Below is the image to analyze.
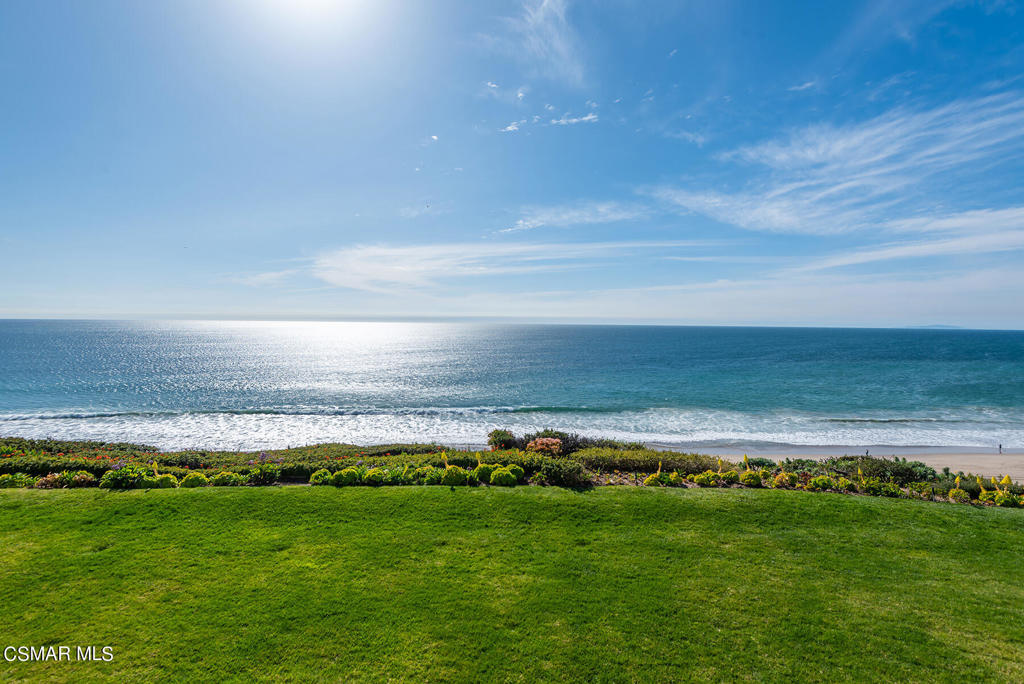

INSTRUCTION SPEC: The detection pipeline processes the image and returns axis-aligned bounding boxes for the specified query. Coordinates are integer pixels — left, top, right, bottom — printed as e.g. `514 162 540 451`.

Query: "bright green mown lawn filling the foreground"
0 487 1024 682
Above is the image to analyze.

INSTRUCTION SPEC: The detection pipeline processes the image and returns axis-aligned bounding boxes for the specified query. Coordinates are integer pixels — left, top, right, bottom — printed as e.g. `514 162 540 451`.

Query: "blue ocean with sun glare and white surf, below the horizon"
0 320 1024 448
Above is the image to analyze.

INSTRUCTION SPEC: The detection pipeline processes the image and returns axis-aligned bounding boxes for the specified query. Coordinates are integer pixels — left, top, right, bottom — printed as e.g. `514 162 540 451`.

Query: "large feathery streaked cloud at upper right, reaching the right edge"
650 92 1024 234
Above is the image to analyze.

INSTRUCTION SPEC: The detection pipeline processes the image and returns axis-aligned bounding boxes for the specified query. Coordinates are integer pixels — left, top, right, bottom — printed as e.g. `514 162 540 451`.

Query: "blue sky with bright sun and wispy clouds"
0 0 1024 329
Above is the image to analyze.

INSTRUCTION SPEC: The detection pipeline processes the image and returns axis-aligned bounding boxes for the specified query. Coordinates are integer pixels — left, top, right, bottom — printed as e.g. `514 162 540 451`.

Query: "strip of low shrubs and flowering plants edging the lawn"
0 438 1024 508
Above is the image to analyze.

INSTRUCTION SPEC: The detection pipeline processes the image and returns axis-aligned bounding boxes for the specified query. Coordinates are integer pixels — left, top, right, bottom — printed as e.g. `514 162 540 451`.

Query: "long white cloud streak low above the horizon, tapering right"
312 241 699 293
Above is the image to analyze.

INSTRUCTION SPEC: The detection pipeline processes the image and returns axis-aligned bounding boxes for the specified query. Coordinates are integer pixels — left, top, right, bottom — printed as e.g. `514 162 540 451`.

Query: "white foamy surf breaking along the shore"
0 407 1024 450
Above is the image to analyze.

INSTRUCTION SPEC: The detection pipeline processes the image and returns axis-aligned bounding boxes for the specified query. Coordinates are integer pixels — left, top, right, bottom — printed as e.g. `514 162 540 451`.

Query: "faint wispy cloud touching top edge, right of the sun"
500 0 585 87
